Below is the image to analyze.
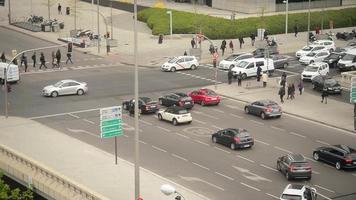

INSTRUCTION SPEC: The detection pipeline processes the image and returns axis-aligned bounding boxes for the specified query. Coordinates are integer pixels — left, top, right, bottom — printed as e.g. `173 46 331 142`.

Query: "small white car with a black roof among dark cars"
158 106 193 126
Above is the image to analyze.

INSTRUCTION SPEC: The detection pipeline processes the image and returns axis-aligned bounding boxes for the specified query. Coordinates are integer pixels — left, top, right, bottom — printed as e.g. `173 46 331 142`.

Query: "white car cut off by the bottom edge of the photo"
279 184 318 200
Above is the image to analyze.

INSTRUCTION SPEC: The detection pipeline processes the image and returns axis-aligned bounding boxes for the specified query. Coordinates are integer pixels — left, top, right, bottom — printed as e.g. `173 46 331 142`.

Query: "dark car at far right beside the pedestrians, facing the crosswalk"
312 76 342 94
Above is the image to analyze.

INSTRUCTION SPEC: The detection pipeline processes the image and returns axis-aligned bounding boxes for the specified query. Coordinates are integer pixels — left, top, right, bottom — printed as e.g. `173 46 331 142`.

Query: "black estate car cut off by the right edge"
313 145 356 170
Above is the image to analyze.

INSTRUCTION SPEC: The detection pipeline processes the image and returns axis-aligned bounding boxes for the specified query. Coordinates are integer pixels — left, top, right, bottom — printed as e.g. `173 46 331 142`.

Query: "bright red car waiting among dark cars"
188 88 221 106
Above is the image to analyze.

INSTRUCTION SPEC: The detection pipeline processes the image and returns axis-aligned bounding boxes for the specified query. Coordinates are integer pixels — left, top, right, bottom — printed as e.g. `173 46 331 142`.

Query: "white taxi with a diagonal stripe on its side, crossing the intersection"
161 56 199 72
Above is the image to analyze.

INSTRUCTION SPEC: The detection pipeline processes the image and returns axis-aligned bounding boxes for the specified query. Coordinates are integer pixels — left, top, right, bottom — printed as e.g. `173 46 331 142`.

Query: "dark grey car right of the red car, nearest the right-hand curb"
245 99 282 119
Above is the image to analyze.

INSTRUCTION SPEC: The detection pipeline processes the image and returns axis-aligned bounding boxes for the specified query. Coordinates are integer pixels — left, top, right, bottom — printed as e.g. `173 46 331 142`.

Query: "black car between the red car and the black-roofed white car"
158 92 194 109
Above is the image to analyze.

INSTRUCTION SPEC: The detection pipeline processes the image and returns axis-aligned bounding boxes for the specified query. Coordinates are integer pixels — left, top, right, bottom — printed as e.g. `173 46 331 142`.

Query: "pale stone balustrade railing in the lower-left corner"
0 144 107 200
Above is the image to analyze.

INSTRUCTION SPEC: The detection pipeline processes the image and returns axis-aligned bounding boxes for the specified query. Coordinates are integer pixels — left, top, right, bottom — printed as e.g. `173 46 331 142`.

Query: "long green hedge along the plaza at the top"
138 8 356 39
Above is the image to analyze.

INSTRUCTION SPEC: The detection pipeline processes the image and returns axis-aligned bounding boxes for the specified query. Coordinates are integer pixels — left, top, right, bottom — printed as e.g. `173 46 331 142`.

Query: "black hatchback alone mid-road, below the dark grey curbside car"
211 128 254 150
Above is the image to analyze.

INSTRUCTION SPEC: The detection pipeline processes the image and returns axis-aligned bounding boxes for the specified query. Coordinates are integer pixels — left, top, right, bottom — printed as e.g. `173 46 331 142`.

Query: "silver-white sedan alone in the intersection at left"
42 80 88 97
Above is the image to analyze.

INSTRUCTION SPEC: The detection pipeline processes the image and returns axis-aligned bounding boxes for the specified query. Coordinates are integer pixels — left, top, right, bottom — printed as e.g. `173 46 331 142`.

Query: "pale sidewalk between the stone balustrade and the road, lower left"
0 116 208 200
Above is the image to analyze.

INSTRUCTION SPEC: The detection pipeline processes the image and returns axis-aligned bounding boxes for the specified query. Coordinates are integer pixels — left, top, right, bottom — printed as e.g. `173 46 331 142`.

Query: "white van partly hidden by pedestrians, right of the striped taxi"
231 58 274 79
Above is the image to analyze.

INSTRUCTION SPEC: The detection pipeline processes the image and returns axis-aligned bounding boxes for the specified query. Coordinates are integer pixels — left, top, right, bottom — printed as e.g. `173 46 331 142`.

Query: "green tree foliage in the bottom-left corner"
0 172 34 200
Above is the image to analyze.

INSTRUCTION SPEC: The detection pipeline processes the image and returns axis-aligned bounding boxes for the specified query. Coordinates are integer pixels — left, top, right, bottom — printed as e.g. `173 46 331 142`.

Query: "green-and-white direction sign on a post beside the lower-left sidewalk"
100 106 123 164
